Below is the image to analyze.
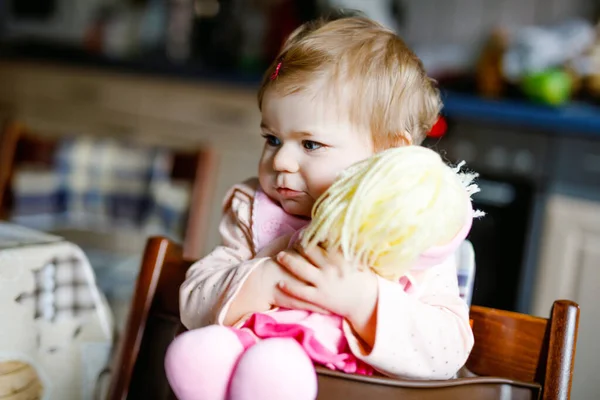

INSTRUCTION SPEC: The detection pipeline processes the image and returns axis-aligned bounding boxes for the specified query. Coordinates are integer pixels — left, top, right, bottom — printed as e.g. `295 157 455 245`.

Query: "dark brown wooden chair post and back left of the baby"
108 238 191 400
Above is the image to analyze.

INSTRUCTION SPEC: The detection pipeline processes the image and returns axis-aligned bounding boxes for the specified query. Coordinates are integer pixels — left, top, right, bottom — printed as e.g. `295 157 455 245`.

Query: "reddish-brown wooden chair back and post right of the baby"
466 300 579 399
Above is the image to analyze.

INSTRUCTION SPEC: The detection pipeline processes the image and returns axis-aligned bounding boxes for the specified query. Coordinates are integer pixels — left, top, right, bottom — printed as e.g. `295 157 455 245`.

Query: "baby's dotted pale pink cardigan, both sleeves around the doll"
180 179 473 379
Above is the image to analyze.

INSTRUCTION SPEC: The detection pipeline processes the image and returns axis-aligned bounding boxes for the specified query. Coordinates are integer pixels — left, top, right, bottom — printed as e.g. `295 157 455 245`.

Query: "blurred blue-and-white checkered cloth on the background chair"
13 137 190 238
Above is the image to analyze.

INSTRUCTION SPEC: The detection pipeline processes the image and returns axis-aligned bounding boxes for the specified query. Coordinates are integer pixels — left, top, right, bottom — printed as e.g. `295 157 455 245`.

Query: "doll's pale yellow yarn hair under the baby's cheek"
301 146 477 281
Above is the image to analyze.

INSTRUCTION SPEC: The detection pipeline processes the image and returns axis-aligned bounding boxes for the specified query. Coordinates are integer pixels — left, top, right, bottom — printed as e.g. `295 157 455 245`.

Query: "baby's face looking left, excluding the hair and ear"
259 90 374 217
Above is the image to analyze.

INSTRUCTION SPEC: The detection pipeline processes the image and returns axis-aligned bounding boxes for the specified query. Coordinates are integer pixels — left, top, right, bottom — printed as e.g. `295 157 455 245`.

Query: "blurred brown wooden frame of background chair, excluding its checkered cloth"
0 121 217 259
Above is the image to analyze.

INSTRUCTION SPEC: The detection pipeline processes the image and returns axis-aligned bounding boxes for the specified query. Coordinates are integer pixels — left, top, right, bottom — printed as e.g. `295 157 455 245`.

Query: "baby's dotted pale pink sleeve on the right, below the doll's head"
344 255 473 379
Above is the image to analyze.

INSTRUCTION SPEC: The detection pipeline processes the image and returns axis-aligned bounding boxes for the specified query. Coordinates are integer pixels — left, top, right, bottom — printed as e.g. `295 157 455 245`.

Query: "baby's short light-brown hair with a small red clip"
258 17 441 151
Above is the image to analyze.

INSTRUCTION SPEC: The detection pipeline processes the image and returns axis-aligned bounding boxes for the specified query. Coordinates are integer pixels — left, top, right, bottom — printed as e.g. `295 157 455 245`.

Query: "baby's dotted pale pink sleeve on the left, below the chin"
179 182 266 329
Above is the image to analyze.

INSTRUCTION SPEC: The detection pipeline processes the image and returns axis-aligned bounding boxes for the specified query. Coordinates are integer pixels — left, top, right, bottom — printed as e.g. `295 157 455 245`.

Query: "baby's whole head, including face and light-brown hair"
258 17 440 217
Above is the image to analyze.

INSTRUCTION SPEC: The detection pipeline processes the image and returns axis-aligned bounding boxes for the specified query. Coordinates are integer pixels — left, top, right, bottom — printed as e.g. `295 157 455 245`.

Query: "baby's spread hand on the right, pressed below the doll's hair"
276 246 378 330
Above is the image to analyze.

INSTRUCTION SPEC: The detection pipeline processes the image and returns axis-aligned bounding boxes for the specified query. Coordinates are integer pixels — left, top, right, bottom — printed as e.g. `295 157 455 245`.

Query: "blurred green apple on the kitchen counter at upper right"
521 69 573 106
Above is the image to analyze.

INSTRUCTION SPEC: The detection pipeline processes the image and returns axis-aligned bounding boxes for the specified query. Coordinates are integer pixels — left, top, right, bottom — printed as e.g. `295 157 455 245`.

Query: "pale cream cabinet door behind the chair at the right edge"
533 195 600 400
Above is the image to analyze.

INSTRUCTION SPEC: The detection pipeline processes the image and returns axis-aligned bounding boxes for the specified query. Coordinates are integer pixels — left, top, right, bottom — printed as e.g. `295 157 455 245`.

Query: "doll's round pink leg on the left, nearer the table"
165 325 244 400
